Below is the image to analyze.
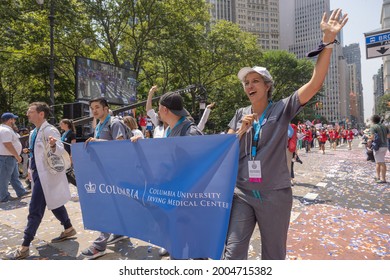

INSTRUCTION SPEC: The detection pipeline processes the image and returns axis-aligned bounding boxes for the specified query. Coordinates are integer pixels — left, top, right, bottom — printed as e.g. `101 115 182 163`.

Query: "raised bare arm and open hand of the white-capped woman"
298 9 348 105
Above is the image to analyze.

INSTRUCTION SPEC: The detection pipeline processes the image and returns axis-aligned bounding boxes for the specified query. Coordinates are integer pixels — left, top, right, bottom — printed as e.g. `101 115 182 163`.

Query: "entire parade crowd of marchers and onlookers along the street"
0 9 364 260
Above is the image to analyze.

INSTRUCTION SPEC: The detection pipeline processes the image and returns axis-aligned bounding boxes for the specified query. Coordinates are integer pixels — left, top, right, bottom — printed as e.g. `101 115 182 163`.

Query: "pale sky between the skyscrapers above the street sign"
330 0 383 122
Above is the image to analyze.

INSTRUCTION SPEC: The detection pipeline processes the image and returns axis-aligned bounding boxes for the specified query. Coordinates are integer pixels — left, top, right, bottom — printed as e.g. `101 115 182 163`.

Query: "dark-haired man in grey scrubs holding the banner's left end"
81 97 128 260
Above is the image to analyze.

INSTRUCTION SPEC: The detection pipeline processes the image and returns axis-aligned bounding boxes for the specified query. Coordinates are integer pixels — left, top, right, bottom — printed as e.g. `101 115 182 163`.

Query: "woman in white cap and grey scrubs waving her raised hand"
223 9 348 260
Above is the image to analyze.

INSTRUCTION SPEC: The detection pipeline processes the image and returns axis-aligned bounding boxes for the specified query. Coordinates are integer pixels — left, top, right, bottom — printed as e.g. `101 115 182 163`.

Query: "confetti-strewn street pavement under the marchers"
0 139 390 260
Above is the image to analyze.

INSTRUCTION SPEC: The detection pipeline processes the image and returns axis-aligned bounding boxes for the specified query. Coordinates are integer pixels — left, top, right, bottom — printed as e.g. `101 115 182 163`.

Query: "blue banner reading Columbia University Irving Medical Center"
72 135 239 259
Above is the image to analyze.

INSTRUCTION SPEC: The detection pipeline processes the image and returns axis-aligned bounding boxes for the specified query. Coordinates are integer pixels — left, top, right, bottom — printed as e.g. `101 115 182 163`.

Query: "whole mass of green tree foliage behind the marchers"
0 0 313 132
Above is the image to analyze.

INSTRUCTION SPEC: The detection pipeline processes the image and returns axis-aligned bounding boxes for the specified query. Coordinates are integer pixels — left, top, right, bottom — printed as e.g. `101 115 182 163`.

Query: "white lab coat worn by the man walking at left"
29 121 71 210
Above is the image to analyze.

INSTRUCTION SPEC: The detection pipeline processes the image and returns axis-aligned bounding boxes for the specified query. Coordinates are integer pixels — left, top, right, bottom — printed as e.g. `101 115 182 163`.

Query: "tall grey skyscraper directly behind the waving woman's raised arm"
279 0 349 123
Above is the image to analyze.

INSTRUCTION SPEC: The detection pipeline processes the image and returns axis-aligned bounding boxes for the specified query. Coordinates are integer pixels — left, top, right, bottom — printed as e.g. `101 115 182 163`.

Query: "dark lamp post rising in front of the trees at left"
36 0 55 124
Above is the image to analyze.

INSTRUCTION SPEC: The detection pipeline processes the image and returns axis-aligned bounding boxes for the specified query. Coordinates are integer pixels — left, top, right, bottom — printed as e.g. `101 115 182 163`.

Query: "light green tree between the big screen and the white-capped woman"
145 21 261 120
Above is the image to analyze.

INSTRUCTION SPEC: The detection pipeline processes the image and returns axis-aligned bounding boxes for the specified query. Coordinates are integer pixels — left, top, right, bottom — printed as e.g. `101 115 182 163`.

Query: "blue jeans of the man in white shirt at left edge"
0 156 26 202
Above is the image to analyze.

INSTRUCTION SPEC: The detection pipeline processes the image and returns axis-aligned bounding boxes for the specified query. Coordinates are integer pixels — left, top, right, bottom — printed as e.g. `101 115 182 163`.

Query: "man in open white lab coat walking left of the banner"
6 102 76 259
